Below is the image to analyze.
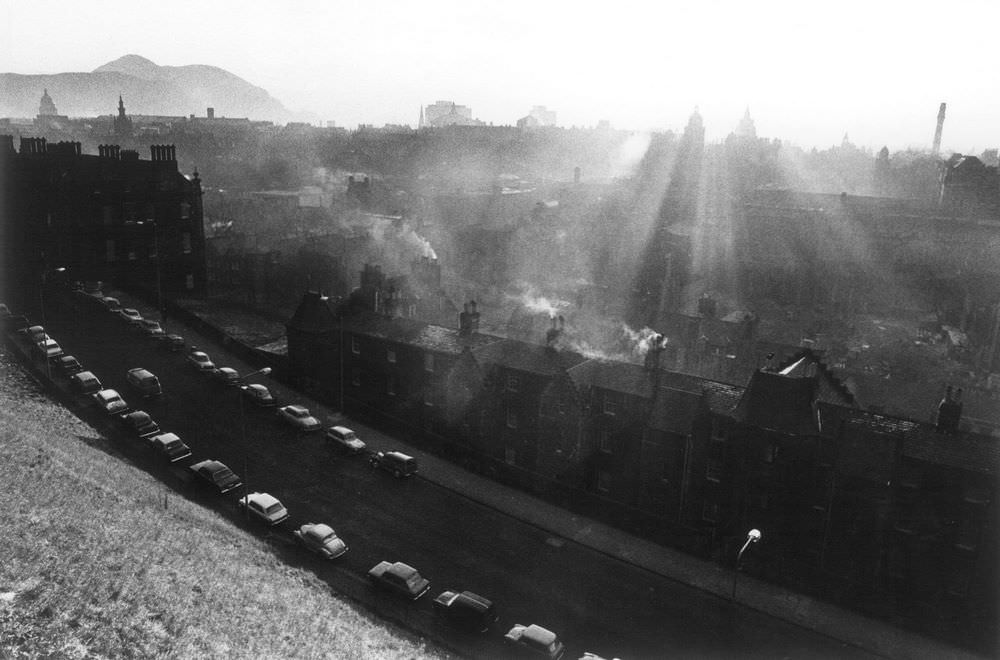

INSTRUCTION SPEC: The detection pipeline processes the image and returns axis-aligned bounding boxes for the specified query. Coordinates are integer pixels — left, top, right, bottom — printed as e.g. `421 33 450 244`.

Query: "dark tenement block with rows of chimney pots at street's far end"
0 136 206 310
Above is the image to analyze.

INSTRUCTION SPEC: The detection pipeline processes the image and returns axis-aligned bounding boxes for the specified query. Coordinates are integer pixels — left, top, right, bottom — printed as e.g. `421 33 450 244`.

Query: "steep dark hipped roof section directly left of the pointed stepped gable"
736 371 818 435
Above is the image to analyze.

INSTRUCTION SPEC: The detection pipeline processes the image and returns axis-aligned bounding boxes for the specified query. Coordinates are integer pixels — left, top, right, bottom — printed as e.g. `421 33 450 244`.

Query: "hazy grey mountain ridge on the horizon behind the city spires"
0 55 293 122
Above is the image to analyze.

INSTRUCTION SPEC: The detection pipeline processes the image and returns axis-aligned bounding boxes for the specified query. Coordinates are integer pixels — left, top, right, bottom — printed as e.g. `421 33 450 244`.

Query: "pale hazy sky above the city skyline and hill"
0 0 1000 153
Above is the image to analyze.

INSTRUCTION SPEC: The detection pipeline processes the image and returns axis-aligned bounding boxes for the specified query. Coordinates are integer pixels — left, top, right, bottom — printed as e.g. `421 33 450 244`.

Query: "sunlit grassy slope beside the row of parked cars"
0 349 443 658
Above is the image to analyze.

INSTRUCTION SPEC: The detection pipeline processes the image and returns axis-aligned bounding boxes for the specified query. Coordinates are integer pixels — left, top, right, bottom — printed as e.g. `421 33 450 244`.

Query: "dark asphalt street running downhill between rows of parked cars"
18 292 871 658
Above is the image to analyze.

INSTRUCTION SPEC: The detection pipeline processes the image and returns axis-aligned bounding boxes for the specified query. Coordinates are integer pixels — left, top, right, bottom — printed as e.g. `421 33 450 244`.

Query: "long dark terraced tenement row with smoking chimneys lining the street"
287 278 1000 644
